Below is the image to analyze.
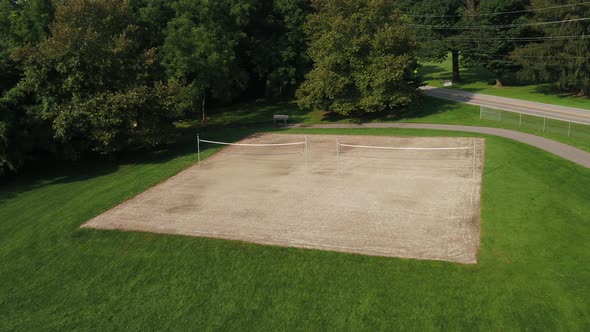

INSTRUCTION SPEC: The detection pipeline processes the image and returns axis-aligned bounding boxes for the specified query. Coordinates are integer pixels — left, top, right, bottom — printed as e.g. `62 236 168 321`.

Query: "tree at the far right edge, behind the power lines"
512 0 590 96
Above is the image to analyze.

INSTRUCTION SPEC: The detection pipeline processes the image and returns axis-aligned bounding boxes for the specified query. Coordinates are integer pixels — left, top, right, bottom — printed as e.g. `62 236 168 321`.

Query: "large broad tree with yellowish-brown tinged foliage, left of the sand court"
20 0 183 157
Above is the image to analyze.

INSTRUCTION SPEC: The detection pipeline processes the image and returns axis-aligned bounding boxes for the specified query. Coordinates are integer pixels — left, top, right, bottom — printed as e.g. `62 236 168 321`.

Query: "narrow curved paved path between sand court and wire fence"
290 123 590 168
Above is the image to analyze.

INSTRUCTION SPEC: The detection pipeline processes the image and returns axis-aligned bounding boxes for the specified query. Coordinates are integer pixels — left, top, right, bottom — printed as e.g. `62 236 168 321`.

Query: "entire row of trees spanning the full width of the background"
0 0 590 173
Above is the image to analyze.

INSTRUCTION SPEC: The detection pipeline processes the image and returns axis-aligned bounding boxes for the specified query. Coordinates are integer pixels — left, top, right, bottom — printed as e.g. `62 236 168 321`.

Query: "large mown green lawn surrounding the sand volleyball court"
0 128 590 331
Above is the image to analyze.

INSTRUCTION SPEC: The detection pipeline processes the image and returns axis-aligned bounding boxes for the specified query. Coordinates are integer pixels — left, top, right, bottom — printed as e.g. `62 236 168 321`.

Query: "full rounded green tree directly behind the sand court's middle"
297 0 420 115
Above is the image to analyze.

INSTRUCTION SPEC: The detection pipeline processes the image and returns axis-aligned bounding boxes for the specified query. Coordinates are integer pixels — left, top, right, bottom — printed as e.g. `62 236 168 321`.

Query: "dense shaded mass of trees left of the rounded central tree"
0 0 310 172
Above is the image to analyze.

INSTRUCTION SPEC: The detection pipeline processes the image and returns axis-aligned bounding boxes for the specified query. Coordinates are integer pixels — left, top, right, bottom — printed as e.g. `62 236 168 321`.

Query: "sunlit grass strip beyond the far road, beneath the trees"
420 57 590 110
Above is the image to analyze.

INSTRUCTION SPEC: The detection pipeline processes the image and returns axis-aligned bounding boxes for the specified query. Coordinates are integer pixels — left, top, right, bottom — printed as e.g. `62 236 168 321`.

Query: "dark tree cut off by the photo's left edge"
0 0 54 174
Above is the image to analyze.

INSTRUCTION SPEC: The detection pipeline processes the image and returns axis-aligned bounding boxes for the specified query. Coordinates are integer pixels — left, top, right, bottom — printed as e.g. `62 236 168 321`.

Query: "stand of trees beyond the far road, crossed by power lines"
408 0 590 96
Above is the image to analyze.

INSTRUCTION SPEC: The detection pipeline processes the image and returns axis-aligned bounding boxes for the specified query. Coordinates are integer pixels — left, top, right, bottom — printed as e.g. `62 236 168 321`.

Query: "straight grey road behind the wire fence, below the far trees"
422 86 590 125
